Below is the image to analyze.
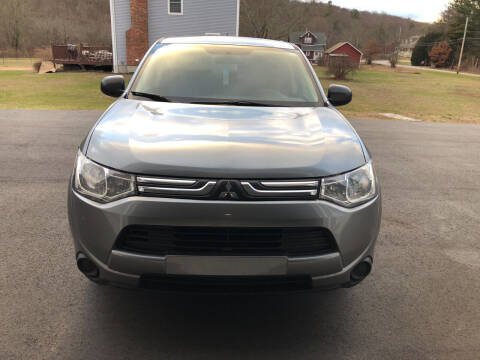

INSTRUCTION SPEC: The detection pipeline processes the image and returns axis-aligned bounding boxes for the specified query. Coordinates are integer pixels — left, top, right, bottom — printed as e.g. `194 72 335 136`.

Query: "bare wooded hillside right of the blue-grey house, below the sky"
240 0 430 53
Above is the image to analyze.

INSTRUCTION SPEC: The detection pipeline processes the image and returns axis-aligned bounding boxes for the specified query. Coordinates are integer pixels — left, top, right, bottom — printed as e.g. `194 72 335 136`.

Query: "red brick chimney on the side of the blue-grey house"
126 0 148 66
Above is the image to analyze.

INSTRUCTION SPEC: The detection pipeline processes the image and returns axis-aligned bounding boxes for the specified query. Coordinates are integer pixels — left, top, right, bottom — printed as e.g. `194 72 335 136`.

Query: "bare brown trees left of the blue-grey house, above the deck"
0 0 111 56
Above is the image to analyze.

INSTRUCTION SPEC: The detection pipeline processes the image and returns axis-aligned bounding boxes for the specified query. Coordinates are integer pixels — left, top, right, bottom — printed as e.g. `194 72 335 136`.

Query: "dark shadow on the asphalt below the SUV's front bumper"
67 284 349 358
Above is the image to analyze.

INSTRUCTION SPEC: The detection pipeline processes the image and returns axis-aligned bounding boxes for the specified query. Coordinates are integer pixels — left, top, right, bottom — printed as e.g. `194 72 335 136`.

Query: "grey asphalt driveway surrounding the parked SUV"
0 110 480 360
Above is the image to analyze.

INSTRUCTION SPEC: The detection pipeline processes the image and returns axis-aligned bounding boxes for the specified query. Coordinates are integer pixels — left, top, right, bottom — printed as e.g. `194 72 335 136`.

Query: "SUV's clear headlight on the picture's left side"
74 151 135 203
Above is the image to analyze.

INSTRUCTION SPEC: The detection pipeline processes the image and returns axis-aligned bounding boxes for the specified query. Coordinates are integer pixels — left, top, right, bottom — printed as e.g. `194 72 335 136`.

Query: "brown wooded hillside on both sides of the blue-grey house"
0 0 428 54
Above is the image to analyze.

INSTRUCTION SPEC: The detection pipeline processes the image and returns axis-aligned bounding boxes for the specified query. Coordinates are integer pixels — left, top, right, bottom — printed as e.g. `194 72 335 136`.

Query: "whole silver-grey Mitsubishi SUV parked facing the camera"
68 36 381 292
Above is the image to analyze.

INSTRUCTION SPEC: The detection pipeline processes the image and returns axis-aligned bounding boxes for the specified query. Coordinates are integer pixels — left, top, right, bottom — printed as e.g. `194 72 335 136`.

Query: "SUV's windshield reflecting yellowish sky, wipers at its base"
131 44 323 106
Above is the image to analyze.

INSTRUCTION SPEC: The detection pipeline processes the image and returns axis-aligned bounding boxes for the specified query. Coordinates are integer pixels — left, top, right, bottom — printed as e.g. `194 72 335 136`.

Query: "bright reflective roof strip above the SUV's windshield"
158 36 295 50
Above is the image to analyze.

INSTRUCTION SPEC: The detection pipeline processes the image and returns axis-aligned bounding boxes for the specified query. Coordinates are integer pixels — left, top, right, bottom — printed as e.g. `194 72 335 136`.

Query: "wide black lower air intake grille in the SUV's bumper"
116 225 337 257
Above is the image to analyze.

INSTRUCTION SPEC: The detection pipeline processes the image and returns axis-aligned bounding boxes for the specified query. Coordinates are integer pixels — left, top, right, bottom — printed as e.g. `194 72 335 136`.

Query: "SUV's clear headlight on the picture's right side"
320 162 377 207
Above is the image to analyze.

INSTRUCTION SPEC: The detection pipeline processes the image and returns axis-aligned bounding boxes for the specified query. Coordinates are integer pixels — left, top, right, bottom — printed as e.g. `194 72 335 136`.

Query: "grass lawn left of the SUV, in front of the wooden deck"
0 70 129 110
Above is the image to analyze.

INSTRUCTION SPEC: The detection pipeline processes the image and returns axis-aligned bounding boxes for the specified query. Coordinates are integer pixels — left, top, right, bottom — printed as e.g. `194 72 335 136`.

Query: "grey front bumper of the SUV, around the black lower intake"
68 183 381 288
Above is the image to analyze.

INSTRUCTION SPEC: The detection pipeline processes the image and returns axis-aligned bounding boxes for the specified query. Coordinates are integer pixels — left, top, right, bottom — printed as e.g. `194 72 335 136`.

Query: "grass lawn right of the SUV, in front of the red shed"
315 65 480 123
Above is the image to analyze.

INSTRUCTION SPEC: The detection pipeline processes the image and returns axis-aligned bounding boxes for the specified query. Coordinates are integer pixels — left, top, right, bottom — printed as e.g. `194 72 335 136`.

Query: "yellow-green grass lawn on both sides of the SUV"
0 64 480 123
